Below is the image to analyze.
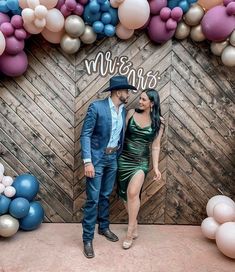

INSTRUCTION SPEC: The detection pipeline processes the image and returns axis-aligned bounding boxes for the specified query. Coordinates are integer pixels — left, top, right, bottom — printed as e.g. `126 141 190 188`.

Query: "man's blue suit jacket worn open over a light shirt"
80 98 126 165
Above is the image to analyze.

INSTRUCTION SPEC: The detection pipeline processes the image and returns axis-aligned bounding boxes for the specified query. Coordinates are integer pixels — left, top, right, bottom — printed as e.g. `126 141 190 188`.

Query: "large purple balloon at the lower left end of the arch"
0 51 28 77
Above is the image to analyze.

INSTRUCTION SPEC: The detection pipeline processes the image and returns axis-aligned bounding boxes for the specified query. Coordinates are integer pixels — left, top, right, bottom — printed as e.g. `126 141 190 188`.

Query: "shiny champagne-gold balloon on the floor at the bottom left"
0 214 19 237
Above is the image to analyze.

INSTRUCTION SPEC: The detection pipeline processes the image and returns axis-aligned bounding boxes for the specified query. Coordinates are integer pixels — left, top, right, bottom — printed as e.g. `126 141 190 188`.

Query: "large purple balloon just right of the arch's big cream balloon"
147 15 175 43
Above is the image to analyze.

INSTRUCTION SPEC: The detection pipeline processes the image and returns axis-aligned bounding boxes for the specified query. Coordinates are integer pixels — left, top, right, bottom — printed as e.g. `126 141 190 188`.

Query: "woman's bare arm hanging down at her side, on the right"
152 117 165 180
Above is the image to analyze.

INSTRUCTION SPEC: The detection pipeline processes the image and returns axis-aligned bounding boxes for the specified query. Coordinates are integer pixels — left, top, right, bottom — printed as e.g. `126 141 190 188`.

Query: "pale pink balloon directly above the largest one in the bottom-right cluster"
213 202 235 224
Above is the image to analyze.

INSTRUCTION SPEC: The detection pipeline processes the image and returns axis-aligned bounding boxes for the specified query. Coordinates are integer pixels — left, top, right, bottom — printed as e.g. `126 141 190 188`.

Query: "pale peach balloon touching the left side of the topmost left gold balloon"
46 8 64 32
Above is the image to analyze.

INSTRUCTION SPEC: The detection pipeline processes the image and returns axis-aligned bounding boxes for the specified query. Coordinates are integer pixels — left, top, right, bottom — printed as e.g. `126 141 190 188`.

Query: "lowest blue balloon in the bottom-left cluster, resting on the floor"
19 201 44 230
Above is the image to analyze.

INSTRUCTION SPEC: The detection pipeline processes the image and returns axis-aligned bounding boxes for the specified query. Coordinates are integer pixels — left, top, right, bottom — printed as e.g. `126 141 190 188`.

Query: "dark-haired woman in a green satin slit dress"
118 89 164 249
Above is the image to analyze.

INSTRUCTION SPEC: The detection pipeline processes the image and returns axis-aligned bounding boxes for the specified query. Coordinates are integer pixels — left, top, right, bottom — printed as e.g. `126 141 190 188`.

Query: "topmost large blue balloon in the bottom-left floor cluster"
12 174 39 201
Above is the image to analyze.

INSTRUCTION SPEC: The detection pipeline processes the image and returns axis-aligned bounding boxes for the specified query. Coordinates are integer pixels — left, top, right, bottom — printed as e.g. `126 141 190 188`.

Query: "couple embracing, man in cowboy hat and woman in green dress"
80 76 164 258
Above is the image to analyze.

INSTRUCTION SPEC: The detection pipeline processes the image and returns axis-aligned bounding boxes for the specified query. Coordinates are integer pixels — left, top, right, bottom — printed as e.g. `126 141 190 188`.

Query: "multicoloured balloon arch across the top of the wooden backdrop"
0 0 235 77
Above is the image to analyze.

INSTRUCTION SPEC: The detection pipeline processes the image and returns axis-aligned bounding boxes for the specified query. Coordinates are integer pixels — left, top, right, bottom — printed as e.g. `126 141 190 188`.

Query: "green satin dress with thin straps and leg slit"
117 116 154 201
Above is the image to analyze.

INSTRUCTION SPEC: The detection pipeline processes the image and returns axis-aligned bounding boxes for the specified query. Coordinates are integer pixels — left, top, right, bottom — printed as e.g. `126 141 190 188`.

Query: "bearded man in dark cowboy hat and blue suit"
80 76 136 258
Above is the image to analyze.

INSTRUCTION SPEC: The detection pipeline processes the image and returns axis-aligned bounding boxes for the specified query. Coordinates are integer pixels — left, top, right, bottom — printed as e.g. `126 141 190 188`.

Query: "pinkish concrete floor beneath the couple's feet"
0 224 235 272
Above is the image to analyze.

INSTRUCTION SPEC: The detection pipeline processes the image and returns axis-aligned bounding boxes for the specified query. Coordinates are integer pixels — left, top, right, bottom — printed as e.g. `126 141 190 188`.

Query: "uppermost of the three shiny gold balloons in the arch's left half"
64 15 85 38
